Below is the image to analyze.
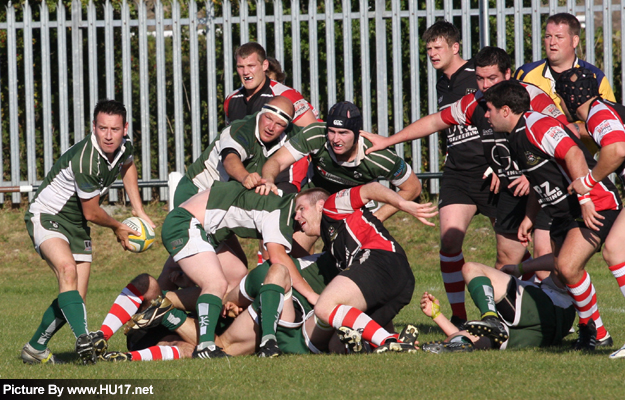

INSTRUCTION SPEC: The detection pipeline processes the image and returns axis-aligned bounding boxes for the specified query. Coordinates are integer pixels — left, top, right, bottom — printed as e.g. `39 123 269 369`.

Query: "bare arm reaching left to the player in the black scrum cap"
360 112 451 154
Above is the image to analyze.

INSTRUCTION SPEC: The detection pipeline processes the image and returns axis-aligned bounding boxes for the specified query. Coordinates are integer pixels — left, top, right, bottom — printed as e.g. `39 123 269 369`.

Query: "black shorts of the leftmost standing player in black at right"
438 171 498 218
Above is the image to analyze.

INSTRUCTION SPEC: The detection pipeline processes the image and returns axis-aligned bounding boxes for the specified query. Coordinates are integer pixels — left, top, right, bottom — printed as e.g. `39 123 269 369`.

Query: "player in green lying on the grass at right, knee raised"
421 255 575 353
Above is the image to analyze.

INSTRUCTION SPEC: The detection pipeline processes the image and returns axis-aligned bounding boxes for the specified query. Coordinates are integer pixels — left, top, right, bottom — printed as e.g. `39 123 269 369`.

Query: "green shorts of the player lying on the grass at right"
501 279 576 349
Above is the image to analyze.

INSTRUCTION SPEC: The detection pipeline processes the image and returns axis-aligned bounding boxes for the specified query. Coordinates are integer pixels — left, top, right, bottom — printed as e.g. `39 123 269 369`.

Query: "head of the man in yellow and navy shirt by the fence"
545 13 581 68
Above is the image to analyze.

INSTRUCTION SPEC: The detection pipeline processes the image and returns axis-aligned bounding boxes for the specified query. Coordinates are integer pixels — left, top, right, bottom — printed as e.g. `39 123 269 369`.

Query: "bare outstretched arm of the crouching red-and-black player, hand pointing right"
360 182 438 226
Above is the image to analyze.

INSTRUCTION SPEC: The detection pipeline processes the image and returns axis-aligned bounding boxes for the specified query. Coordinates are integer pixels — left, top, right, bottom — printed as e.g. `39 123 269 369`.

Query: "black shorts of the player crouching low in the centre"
339 249 415 326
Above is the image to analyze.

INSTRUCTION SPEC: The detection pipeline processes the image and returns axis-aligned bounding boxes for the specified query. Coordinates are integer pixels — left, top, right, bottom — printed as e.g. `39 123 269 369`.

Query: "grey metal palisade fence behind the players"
0 0 625 202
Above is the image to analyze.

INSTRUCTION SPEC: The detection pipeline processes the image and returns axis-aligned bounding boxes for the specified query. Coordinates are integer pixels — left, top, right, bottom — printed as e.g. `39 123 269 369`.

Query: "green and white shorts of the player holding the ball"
24 212 92 263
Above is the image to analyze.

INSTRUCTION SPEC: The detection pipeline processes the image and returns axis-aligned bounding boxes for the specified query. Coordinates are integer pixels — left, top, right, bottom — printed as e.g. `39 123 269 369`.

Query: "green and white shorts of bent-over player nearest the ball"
161 207 215 262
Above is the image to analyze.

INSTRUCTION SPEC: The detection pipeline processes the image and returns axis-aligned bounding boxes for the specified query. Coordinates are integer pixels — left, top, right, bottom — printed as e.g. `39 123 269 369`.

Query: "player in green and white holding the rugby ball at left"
21 100 155 364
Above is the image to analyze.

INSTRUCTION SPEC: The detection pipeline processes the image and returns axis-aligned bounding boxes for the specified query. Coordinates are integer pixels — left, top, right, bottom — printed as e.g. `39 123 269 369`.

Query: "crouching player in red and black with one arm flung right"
295 182 437 352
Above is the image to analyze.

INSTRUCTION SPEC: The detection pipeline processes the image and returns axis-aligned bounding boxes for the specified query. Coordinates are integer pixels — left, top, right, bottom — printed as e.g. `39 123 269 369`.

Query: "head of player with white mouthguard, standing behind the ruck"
234 42 269 92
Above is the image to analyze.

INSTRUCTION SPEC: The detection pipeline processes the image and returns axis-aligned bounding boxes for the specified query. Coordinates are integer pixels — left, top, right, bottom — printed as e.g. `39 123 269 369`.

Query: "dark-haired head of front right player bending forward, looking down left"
484 80 530 132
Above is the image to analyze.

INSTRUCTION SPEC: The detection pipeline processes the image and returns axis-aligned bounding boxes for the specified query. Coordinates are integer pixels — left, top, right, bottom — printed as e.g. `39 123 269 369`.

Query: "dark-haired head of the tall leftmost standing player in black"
422 20 460 71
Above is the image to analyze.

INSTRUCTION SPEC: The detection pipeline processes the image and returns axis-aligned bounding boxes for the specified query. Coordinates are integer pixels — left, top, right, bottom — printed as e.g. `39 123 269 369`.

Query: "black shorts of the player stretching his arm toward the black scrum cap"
494 190 551 234
